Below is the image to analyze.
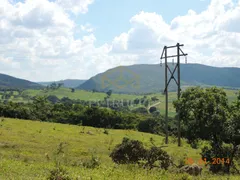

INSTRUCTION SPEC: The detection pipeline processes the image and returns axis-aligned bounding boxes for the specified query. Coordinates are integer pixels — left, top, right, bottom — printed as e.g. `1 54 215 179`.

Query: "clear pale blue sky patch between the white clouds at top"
72 0 210 45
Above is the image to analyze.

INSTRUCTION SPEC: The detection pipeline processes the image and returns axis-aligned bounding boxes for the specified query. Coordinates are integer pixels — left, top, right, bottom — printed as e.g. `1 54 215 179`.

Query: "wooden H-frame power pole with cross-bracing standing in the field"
160 43 188 146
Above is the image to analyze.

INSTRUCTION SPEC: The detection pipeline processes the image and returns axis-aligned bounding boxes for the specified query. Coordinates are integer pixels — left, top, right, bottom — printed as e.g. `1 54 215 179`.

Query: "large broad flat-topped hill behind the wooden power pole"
77 64 240 93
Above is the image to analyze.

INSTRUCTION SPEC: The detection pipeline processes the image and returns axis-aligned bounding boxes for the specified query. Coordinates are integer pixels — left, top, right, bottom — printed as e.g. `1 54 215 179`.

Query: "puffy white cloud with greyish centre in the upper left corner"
10 0 74 29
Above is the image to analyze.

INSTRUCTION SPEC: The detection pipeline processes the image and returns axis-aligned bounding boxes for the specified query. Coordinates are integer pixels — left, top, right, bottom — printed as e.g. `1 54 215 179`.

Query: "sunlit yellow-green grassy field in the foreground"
0 118 240 180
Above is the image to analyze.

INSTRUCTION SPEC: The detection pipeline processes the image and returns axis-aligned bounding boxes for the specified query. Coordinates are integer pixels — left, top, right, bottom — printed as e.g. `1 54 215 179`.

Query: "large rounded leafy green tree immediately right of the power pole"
173 87 229 143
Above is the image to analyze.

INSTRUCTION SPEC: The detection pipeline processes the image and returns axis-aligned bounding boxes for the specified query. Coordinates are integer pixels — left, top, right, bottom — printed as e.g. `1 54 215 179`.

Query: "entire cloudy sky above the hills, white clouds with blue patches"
0 0 240 81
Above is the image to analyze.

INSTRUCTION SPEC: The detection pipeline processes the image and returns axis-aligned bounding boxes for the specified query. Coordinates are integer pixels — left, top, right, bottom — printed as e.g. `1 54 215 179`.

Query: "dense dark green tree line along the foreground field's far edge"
0 96 170 133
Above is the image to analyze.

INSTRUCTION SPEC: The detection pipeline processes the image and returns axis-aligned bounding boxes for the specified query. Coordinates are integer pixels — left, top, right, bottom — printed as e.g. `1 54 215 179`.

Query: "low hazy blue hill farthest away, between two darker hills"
37 79 86 88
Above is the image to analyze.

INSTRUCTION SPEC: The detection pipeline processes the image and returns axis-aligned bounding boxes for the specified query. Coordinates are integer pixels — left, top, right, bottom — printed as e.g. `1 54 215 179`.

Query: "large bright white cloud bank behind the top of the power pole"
112 0 240 67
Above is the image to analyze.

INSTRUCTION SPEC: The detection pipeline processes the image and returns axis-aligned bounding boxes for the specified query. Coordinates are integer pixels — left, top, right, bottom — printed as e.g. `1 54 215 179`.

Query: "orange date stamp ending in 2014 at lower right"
185 158 230 165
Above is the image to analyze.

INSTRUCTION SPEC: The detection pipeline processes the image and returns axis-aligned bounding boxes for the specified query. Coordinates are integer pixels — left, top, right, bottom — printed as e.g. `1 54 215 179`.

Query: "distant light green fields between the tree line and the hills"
0 88 237 116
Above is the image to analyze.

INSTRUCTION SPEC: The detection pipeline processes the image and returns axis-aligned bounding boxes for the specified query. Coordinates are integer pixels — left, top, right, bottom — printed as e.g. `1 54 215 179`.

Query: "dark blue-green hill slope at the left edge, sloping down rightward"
0 74 42 89
